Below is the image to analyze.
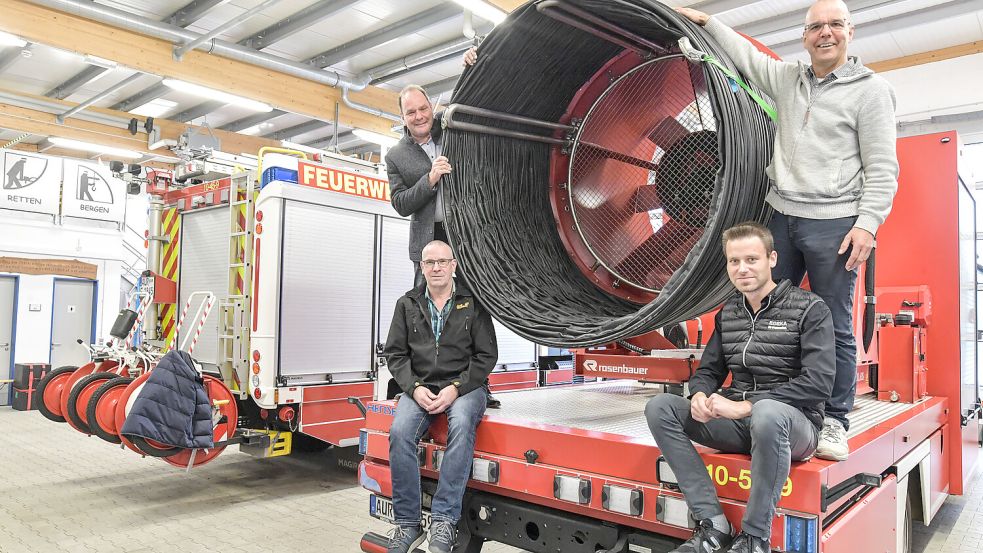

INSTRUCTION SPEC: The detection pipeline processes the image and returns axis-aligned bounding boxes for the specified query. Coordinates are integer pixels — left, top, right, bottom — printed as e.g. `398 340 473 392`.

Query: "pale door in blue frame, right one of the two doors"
50 279 96 368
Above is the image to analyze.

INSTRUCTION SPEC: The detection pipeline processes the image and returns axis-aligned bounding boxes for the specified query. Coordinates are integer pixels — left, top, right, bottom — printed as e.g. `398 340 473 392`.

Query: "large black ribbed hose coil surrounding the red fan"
442 0 774 347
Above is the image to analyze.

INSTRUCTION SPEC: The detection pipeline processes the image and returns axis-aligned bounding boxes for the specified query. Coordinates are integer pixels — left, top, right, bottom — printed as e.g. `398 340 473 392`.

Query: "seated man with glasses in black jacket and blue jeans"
385 240 498 553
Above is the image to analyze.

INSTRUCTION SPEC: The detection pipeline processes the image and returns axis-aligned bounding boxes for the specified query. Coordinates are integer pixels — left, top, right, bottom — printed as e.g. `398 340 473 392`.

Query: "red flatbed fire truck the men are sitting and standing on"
359 132 983 553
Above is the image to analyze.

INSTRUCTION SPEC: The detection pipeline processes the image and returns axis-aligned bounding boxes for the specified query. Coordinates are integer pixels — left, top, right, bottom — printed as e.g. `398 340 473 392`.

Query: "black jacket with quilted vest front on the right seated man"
689 280 836 428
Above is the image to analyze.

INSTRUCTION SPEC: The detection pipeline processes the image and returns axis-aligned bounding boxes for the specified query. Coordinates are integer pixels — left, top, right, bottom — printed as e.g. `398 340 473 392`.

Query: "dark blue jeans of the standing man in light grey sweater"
768 211 857 430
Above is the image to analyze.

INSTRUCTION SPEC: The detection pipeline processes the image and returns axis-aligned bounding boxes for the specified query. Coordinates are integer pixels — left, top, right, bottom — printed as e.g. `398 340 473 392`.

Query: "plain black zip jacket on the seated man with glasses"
385 282 498 396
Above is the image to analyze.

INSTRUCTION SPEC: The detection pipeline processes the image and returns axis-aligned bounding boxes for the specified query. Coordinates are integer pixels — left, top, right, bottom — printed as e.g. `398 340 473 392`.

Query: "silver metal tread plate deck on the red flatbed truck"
486 380 928 445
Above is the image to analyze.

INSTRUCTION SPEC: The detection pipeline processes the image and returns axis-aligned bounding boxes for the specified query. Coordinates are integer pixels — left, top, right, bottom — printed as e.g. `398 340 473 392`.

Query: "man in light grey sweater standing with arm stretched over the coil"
676 0 898 460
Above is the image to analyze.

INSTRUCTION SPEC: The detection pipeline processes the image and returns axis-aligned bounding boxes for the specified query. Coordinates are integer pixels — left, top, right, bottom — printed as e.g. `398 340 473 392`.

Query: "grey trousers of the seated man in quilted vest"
645 394 819 541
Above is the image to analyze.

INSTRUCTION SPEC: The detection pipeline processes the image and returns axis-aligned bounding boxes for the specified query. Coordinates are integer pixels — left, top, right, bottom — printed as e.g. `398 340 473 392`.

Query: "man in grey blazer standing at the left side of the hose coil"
386 85 500 408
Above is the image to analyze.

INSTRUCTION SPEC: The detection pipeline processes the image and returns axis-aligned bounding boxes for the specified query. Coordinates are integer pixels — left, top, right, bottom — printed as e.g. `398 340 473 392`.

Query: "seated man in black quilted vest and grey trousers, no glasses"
645 222 836 553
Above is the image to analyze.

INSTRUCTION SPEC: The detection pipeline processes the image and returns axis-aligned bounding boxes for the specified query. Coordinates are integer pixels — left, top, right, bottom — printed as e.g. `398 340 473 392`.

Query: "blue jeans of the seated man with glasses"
389 388 487 526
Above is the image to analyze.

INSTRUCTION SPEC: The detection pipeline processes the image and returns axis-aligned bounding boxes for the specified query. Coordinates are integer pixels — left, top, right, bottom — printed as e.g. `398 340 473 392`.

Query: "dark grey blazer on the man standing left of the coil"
386 112 444 262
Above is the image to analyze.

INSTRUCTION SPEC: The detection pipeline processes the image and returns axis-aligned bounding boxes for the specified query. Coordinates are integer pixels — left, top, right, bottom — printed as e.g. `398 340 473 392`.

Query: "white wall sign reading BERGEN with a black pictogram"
61 159 126 222
